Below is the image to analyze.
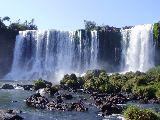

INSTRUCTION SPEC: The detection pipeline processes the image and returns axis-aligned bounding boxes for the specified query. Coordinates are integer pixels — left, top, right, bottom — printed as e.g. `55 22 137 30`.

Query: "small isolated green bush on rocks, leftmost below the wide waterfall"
33 78 52 90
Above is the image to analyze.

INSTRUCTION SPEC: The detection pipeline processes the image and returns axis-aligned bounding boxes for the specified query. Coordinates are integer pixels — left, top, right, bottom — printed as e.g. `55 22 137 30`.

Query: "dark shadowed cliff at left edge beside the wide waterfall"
0 29 18 79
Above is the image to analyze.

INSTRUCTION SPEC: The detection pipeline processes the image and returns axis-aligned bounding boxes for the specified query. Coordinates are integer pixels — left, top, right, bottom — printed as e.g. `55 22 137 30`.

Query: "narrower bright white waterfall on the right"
121 24 155 72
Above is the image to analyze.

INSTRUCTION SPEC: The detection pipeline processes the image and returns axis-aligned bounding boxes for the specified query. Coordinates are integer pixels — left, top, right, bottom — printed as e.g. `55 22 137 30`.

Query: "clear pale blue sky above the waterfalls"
0 0 160 30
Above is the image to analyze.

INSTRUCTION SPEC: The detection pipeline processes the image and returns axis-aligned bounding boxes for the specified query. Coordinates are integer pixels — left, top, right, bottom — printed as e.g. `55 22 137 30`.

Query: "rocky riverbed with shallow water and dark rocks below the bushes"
0 82 160 120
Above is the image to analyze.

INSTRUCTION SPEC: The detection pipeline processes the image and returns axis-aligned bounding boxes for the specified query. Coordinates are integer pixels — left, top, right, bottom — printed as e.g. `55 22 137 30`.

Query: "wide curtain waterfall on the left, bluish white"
5 30 99 80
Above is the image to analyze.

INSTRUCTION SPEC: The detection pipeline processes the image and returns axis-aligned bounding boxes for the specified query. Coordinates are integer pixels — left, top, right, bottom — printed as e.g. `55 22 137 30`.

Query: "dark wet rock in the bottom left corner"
0 110 23 120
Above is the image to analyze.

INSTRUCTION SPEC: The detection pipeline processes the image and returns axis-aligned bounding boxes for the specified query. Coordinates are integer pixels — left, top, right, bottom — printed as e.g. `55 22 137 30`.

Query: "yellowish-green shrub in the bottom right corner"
123 105 160 120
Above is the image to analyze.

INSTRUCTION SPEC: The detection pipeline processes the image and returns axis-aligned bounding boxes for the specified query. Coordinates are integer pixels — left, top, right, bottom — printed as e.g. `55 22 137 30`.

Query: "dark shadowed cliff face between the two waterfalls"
98 30 121 72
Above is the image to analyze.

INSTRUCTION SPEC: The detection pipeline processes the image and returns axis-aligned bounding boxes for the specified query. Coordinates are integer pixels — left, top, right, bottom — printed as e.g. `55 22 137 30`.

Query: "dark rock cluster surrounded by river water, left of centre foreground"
25 93 88 111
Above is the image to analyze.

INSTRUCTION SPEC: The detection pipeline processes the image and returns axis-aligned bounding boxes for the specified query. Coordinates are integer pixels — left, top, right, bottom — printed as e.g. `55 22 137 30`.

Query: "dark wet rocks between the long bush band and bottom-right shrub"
84 94 127 116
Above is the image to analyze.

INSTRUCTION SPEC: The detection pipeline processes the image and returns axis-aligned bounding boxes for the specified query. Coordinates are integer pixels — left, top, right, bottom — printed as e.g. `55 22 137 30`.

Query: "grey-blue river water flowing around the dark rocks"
0 81 160 120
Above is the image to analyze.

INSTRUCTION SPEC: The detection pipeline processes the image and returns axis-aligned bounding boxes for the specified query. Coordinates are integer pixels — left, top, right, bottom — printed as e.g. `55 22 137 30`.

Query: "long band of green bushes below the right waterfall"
60 66 160 99
